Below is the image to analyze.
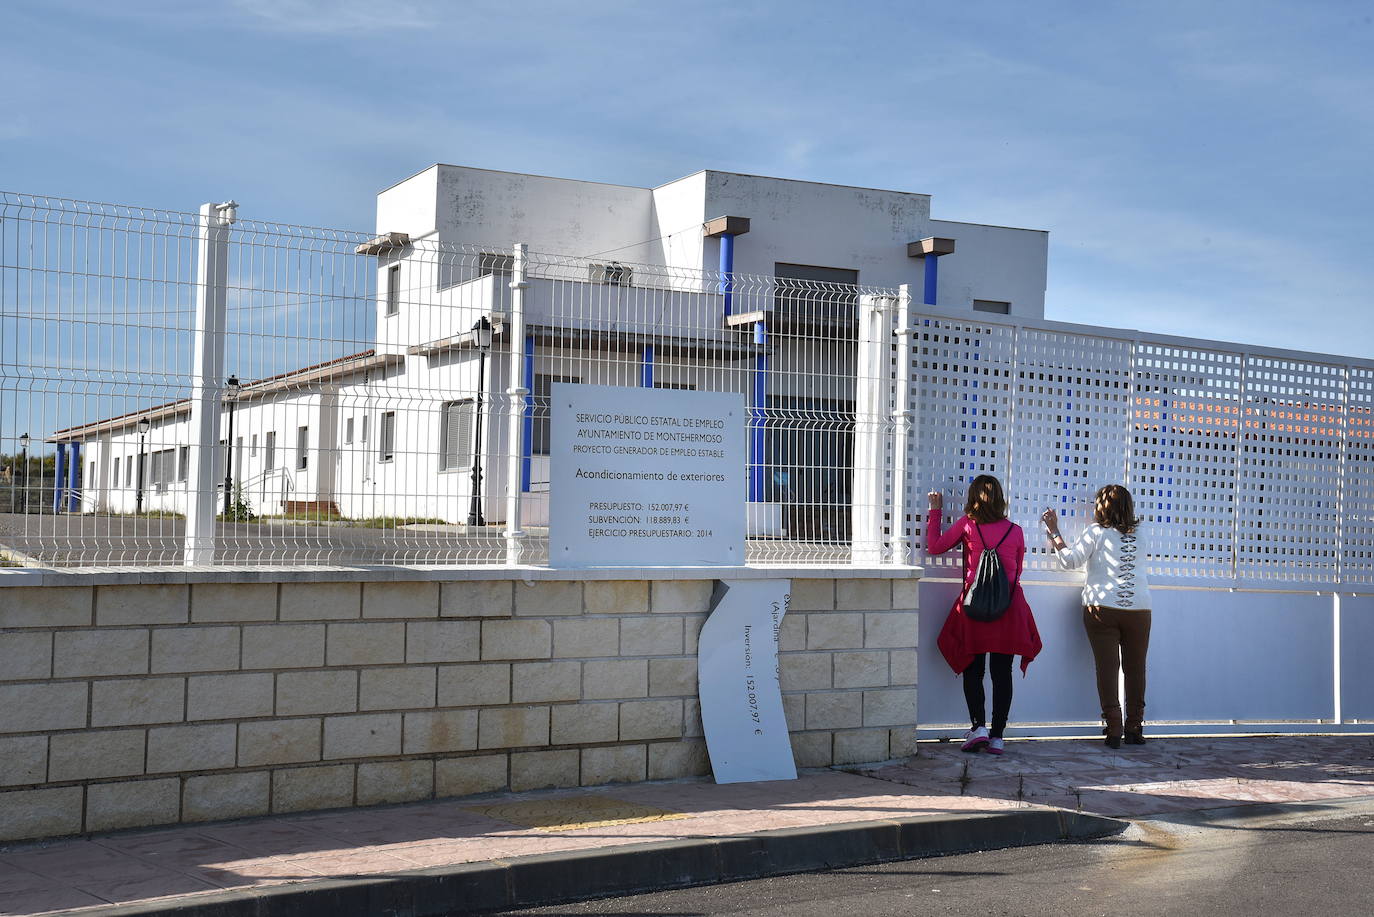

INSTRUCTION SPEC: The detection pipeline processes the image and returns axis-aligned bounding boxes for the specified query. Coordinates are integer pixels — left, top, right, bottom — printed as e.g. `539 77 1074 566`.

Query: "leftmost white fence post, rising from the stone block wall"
183 201 238 565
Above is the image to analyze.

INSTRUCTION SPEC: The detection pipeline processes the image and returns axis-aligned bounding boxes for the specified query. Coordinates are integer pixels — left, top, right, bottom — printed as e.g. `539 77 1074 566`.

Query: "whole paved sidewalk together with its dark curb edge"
0 736 1374 917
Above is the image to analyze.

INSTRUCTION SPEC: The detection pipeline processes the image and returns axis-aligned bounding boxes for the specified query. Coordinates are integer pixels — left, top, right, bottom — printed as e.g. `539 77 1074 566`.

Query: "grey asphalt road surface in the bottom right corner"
507 800 1374 917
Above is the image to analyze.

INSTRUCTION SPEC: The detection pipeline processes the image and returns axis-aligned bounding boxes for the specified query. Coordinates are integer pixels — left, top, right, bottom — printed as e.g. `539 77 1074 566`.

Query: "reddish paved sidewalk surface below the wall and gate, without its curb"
0 736 1374 916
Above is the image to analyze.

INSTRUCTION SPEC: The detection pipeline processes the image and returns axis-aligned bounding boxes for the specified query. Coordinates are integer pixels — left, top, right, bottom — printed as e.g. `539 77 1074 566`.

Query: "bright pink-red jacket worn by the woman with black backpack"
926 510 1041 675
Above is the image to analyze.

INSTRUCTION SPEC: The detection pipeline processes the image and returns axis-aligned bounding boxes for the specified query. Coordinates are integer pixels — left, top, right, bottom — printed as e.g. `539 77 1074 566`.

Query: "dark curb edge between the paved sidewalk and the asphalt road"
61 808 1129 917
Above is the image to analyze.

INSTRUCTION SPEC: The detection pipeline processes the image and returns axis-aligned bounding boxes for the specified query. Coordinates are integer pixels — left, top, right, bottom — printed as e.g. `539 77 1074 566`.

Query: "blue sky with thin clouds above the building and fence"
0 0 1374 357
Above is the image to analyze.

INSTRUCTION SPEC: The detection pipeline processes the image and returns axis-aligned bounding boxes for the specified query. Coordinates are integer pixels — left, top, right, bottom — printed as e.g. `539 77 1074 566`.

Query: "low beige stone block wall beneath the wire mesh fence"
0 573 916 840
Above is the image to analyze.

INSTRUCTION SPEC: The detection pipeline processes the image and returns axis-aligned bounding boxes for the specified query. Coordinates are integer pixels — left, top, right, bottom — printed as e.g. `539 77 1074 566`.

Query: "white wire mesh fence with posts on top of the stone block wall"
0 194 896 566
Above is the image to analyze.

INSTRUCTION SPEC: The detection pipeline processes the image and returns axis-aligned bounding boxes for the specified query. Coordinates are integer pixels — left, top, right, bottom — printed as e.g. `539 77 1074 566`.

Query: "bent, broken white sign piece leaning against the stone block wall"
697 580 797 784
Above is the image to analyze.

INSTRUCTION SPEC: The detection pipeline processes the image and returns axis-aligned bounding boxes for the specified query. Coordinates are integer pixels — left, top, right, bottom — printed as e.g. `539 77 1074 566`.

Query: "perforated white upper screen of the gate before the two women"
910 315 1374 591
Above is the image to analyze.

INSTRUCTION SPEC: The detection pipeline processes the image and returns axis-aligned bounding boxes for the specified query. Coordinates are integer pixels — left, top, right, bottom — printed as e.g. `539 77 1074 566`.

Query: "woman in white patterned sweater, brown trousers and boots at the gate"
1041 484 1150 748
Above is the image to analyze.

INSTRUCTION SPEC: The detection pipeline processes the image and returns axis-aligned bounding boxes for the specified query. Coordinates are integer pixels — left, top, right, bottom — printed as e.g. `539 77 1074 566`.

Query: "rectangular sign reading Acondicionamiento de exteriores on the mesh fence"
548 382 745 566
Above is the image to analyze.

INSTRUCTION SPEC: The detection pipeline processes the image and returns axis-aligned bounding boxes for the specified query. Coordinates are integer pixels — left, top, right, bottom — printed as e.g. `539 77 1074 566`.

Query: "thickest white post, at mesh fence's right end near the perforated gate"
851 296 892 564
